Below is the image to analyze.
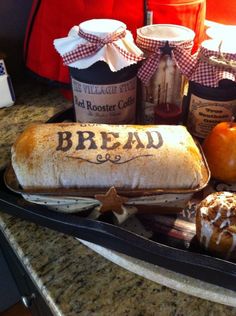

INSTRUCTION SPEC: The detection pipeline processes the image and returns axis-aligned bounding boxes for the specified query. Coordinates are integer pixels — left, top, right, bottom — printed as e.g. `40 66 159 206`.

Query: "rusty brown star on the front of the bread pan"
95 187 128 214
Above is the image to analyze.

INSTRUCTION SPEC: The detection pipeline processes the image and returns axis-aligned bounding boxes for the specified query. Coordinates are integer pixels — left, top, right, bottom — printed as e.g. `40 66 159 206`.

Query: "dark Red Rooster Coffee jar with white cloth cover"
54 19 143 124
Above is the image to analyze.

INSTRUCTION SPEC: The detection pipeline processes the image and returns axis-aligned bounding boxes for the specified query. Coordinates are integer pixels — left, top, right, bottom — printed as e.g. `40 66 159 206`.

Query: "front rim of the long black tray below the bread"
0 171 236 290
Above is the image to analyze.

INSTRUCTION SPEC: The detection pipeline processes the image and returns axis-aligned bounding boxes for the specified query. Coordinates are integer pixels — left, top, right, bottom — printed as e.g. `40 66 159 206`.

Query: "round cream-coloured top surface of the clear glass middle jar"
137 24 195 42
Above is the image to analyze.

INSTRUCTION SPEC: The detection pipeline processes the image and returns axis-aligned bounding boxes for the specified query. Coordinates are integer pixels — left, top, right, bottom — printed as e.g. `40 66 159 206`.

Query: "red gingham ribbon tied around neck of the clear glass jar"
136 28 195 85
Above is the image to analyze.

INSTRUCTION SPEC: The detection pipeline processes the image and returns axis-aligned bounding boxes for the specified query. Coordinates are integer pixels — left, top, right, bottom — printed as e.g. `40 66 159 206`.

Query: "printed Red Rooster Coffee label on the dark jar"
72 77 136 124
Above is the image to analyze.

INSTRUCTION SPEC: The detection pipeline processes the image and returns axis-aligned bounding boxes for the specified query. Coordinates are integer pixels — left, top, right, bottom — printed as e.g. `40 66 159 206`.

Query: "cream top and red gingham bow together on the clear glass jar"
136 24 195 84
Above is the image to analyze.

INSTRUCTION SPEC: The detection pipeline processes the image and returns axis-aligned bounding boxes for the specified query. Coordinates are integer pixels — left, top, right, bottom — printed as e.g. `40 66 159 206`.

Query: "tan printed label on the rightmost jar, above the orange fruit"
187 94 236 138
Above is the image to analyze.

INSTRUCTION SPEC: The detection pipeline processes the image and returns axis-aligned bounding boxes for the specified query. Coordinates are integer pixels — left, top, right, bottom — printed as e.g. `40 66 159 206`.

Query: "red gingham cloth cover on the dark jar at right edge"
188 40 236 88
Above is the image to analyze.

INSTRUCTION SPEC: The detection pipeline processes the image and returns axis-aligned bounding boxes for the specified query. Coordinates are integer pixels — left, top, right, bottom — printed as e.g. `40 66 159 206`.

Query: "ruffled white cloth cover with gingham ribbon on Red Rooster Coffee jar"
54 19 143 71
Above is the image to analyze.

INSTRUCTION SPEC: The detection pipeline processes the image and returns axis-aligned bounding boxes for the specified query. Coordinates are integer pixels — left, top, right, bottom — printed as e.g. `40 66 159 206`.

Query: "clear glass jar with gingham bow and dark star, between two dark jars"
137 24 194 124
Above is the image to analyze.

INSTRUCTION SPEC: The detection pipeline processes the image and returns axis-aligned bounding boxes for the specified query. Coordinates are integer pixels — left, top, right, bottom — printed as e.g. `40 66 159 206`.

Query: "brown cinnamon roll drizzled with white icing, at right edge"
196 192 236 260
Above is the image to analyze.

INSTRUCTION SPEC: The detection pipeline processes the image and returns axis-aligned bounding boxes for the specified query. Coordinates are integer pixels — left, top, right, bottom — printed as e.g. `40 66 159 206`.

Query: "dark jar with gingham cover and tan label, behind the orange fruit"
184 39 236 140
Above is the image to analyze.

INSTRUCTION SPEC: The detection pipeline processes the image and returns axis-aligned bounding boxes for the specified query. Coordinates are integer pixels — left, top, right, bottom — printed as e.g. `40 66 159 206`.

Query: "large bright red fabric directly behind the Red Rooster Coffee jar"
25 0 144 83
